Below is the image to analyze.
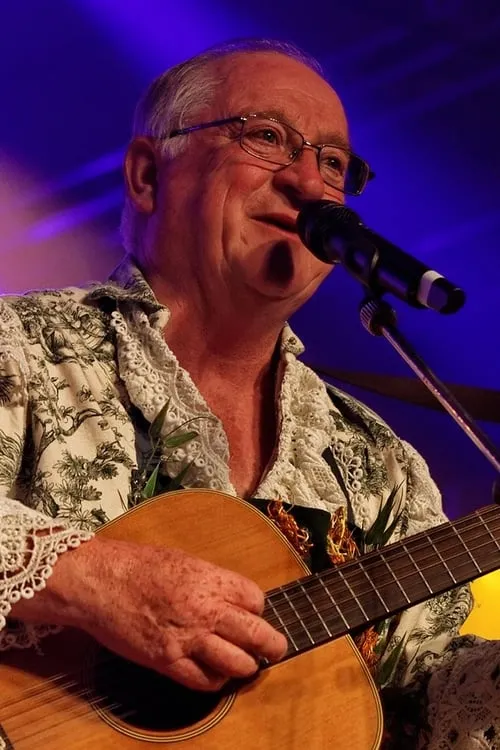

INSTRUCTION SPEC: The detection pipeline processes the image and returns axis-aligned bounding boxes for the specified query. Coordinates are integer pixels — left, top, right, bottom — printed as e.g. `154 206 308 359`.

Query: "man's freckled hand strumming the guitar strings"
12 539 287 690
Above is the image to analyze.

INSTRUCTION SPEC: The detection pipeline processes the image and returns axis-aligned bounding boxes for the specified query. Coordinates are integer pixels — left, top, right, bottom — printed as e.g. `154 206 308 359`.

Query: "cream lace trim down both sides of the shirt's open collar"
106 300 410 527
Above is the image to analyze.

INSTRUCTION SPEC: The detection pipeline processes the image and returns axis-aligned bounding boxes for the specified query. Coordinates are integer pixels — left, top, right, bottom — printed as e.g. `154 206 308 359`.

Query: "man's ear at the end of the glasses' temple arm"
123 136 158 215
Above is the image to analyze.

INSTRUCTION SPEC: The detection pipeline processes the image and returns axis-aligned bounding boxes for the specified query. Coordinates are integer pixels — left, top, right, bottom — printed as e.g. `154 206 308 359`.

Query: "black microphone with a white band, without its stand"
297 200 465 313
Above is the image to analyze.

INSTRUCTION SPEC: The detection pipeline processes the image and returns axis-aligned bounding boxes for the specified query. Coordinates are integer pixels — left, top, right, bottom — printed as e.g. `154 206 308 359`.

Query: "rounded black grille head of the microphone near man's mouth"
297 201 362 263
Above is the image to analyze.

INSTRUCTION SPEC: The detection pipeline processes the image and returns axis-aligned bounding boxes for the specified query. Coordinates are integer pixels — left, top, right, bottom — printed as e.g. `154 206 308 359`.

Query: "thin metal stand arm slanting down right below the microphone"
359 290 500 482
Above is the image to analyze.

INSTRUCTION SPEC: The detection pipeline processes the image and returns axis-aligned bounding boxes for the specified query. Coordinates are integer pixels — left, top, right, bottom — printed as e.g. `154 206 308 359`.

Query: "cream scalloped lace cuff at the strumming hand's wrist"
0 498 92 650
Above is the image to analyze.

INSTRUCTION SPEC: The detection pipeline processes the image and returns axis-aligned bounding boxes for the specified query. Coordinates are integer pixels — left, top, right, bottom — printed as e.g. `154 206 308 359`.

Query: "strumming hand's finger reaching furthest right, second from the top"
215 606 288 661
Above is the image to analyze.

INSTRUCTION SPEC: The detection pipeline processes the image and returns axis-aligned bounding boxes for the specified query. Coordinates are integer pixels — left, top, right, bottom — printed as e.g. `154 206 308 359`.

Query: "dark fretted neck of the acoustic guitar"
265 505 500 653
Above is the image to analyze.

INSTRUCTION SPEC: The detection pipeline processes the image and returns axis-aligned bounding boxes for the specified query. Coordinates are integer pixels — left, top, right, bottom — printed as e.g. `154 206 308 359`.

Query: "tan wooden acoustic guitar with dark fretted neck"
0 490 500 750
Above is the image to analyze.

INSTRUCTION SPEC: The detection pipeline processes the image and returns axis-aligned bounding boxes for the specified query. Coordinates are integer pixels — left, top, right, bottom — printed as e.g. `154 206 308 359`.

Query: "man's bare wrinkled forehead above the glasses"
205 52 348 142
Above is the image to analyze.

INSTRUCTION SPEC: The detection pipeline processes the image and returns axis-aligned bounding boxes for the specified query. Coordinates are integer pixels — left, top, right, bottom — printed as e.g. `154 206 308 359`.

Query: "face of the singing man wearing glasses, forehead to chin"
141 52 347 310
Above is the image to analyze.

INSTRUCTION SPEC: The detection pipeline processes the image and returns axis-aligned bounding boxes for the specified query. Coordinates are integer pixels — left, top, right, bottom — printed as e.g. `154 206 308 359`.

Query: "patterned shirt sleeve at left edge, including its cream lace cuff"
0 300 91 650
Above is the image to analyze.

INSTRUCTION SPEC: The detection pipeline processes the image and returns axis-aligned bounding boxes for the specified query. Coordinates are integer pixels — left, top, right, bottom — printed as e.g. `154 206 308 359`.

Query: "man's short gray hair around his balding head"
120 39 323 256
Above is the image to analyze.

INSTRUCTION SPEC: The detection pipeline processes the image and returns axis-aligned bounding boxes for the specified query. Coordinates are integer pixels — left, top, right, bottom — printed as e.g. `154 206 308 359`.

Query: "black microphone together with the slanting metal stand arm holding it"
297 200 500 487
